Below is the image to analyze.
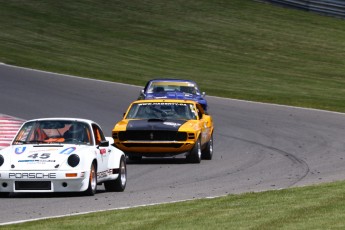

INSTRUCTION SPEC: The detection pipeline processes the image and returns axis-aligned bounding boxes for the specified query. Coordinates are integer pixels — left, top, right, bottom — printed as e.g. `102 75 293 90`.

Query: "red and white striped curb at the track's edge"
0 114 24 149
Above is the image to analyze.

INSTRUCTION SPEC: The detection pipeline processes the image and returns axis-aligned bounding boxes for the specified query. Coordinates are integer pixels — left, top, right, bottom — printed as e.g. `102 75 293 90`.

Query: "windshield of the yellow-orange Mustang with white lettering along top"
126 102 196 120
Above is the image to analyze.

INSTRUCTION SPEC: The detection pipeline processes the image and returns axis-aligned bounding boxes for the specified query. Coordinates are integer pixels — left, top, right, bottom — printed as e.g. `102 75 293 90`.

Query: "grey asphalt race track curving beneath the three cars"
0 65 345 224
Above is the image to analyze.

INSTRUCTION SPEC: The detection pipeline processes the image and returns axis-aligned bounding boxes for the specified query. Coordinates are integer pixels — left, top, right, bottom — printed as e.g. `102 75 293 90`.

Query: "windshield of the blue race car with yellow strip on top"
147 82 200 95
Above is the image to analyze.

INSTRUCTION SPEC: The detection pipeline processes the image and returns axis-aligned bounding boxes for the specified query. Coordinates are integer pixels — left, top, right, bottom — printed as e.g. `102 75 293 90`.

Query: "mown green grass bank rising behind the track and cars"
0 0 345 112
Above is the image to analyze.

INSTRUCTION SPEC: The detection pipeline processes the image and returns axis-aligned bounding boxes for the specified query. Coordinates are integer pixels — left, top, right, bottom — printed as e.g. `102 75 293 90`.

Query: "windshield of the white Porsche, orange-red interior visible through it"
13 120 91 145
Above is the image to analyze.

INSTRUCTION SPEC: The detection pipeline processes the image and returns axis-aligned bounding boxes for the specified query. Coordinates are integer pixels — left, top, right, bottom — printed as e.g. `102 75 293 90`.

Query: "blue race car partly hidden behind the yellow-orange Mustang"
138 79 207 111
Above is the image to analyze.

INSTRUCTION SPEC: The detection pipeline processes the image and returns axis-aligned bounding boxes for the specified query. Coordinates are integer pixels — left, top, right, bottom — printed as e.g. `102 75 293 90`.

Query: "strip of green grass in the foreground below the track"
0 182 345 230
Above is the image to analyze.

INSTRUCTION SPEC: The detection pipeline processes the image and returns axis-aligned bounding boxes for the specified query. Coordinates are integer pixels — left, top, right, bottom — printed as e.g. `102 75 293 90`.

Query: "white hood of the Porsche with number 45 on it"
1 145 86 170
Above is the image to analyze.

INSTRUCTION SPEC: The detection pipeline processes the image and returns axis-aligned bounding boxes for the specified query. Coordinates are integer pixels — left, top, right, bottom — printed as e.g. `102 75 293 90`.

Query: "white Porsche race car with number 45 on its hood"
0 118 127 196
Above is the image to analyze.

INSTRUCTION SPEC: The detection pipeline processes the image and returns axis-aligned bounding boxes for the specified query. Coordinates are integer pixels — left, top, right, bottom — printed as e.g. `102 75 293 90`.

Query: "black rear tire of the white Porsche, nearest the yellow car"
104 156 127 192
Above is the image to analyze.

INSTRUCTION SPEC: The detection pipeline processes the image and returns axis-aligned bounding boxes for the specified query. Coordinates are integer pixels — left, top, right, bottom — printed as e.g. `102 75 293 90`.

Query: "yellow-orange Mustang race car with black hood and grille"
112 99 213 163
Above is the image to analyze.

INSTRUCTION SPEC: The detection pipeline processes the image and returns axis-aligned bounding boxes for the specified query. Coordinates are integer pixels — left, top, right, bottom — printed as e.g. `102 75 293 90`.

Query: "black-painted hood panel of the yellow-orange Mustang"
127 119 187 131
